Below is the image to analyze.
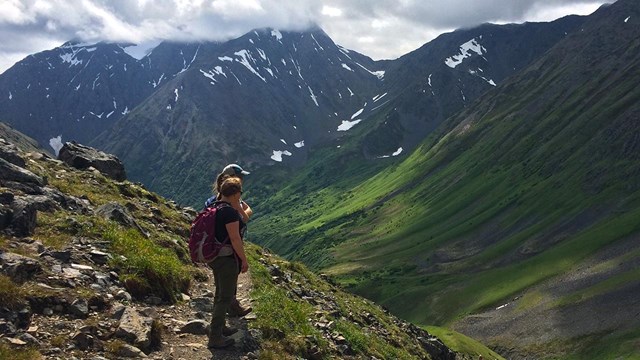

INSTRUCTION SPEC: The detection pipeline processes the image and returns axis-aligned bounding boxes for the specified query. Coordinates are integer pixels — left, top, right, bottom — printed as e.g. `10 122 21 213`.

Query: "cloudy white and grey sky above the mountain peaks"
0 0 615 73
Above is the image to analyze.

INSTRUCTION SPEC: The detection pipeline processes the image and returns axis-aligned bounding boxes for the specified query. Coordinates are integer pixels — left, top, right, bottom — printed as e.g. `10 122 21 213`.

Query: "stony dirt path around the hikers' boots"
149 273 257 360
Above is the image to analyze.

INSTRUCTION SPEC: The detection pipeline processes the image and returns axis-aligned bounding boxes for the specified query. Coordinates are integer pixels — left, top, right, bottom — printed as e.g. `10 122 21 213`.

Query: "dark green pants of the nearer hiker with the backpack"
209 255 238 338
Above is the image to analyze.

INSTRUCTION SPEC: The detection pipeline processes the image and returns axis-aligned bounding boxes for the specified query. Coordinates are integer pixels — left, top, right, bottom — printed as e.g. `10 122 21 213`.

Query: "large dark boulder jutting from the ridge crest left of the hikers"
58 142 127 181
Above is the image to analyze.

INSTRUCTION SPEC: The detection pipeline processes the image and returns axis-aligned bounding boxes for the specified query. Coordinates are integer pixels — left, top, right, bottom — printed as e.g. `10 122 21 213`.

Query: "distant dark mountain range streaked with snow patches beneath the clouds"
0 16 583 205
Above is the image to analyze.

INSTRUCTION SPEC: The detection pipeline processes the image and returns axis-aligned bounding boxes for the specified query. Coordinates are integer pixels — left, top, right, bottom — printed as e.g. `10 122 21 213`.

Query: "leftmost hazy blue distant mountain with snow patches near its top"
0 41 206 155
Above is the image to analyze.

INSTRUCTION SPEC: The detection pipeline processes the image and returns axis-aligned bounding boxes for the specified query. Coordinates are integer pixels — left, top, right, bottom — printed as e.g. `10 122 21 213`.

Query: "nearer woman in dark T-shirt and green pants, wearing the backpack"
207 177 249 349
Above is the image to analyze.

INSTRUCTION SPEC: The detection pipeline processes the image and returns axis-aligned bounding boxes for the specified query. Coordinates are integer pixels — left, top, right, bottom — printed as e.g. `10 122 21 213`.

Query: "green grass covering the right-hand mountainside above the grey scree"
252 2 640 353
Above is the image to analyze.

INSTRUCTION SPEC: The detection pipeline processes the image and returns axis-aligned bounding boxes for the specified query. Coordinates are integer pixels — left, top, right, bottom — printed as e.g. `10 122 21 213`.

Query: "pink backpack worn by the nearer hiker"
189 203 231 264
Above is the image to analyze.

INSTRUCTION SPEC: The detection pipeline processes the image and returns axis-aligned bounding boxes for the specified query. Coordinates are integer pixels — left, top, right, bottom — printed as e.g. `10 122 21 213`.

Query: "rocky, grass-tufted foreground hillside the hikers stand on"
0 125 490 360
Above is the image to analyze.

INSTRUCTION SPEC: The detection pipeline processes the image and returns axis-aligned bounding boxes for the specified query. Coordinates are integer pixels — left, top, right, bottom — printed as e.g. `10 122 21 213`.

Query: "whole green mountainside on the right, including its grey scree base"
252 0 640 359
